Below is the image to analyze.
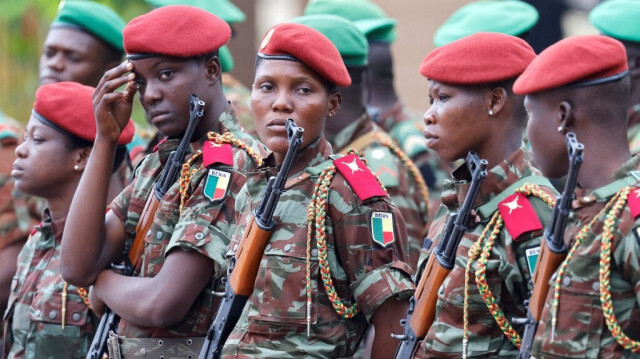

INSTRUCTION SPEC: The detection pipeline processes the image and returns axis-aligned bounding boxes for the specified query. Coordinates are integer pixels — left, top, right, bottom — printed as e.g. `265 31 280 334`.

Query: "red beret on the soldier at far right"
513 35 629 95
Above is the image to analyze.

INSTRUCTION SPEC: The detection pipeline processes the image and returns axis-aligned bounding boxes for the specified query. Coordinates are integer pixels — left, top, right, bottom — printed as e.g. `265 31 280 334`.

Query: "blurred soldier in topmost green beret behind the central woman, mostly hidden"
304 0 450 202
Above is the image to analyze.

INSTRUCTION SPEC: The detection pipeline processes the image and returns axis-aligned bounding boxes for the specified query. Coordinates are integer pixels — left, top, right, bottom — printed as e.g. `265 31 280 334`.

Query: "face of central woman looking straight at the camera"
251 60 340 155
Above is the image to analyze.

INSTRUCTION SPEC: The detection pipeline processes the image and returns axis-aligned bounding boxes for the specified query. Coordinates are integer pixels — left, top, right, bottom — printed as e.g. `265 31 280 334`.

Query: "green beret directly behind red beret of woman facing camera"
291 14 369 66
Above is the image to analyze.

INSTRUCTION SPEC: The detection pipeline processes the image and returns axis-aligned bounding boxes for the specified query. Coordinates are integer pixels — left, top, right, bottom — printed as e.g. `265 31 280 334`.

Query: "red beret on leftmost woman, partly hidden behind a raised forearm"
33 82 135 145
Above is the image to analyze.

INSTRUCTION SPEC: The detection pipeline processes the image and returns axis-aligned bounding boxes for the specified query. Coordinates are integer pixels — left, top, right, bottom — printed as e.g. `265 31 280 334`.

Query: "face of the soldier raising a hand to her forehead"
131 56 211 137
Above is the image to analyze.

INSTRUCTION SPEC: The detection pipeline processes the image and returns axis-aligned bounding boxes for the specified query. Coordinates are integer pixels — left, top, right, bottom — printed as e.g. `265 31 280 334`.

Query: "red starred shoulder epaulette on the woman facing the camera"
333 154 387 201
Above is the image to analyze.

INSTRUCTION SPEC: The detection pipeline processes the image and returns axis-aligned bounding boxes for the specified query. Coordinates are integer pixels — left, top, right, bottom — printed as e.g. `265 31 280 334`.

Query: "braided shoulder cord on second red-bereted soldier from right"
462 183 555 358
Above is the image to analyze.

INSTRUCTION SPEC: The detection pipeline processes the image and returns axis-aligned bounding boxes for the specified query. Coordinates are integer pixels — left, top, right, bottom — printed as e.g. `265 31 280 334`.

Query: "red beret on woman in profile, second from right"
420 32 536 85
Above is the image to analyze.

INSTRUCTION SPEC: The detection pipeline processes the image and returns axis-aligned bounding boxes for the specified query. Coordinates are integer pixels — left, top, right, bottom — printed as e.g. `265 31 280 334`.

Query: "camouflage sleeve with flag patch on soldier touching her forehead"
165 166 245 278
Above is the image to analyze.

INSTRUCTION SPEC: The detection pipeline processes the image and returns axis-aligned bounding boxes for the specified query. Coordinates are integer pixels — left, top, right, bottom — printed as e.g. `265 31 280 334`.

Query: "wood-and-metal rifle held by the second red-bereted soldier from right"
391 151 489 359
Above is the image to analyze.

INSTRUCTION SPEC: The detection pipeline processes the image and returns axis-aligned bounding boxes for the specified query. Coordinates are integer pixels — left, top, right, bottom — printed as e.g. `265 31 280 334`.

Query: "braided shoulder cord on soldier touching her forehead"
180 132 263 213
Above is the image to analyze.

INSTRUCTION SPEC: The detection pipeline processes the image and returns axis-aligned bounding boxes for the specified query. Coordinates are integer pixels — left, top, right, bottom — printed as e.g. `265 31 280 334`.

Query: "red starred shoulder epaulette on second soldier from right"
498 192 542 240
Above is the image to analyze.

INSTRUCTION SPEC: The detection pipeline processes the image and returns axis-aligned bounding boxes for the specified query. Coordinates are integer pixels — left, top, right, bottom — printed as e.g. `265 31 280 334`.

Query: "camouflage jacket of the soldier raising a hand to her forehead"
110 112 262 338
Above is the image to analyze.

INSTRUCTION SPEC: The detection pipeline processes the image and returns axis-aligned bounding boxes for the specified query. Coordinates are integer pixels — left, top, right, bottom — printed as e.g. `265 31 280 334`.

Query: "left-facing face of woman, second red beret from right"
424 80 491 162
